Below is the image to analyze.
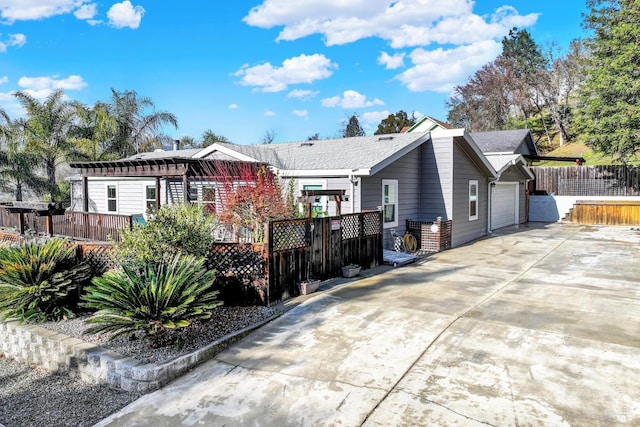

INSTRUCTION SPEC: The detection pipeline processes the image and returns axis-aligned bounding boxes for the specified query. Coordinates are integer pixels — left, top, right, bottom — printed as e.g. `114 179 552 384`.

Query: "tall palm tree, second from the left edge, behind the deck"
14 89 77 201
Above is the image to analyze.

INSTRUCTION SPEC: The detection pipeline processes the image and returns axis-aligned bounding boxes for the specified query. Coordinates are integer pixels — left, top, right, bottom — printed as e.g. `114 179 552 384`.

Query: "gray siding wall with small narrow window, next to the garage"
451 143 488 247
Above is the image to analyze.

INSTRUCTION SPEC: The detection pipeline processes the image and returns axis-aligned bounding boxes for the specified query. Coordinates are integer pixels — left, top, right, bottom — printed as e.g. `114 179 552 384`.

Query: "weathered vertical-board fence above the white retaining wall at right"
531 165 640 196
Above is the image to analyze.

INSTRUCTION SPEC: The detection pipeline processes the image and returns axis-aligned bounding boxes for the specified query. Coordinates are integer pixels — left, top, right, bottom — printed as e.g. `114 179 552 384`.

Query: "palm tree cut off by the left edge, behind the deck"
0 113 48 201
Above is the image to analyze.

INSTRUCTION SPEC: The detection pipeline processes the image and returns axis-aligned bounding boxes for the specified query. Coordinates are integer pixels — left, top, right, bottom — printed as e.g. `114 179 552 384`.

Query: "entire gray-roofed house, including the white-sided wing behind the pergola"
73 129 498 249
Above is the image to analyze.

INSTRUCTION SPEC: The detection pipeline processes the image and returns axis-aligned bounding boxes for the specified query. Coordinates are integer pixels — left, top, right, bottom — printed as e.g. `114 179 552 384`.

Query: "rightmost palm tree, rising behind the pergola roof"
107 89 178 158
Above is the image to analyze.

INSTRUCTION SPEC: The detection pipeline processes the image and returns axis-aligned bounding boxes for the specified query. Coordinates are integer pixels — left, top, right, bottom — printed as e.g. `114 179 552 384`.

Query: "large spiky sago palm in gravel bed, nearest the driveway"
81 253 222 343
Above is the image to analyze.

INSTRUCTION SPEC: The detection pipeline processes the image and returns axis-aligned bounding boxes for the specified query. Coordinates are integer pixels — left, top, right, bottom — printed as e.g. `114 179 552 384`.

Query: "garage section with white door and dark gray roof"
471 129 539 231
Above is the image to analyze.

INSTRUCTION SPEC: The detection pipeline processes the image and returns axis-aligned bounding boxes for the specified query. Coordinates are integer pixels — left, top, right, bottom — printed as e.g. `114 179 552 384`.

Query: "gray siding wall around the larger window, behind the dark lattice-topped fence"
360 147 422 249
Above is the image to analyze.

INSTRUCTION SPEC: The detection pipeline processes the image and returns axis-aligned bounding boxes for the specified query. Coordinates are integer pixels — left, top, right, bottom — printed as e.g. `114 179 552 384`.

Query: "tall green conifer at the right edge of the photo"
576 0 640 162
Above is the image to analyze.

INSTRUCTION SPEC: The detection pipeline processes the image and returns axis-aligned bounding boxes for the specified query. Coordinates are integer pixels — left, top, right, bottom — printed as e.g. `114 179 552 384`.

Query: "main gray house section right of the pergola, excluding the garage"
196 129 497 248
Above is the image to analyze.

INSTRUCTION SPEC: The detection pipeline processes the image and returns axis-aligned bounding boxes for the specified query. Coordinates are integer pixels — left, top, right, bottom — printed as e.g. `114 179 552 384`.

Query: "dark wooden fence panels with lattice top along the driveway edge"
268 211 383 303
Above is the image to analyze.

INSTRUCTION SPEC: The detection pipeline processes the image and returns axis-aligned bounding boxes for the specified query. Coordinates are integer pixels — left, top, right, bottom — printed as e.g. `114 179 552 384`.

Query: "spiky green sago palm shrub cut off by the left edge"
0 239 90 322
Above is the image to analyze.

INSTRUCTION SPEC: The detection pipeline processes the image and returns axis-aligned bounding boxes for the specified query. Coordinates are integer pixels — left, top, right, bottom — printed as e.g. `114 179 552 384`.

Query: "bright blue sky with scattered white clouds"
0 0 586 144
